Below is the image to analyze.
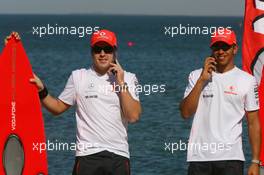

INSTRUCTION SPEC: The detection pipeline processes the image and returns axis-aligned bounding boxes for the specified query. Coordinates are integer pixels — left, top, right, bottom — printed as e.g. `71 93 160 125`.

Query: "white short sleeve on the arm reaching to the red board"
59 75 76 105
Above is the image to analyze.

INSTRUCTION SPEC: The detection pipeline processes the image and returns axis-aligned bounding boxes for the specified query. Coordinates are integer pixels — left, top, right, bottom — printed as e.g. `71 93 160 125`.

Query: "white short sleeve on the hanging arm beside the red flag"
245 78 259 111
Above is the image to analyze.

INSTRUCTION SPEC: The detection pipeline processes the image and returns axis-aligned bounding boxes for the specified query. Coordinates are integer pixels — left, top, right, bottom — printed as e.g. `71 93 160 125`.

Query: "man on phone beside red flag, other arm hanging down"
180 28 261 175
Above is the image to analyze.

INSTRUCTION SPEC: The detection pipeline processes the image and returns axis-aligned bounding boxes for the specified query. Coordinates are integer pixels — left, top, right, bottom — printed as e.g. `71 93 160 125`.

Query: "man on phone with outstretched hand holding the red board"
30 30 141 175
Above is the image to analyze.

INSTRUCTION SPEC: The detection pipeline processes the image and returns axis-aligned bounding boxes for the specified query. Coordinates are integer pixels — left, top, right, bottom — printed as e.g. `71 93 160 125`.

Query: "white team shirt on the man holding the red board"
59 68 139 158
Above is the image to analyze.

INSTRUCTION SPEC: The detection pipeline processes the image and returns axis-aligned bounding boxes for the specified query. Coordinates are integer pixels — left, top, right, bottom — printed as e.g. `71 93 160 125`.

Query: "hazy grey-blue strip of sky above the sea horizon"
0 0 245 16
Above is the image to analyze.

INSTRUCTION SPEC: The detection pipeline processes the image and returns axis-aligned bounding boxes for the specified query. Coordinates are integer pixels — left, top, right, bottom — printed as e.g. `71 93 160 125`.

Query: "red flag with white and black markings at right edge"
242 0 264 163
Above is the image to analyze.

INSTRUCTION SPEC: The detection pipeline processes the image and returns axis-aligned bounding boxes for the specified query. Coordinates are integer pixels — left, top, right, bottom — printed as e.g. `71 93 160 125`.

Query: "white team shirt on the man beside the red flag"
184 67 259 162
